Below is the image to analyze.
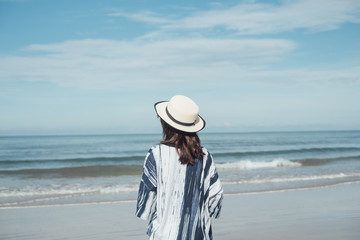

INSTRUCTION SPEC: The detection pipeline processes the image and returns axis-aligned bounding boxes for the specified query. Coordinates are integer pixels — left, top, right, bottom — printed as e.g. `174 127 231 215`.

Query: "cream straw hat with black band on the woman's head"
154 95 205 133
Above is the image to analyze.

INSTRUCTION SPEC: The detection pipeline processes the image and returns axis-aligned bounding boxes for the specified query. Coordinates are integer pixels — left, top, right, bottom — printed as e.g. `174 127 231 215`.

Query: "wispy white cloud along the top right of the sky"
111 0 360 34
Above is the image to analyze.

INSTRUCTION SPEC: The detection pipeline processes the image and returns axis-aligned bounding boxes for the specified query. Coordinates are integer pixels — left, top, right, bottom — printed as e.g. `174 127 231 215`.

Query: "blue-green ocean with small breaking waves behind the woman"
0 131 360 209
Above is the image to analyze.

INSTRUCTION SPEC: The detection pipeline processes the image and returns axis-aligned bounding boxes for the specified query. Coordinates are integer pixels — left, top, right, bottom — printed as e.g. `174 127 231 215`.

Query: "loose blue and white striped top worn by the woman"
136 144 223 240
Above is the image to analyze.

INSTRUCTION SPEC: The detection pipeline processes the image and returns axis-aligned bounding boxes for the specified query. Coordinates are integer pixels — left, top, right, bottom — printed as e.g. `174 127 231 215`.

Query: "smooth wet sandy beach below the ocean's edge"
0 183 360 240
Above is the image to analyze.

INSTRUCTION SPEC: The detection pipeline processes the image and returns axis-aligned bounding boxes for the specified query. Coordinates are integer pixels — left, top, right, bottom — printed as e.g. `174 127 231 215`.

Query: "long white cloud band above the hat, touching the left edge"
0 38 296 88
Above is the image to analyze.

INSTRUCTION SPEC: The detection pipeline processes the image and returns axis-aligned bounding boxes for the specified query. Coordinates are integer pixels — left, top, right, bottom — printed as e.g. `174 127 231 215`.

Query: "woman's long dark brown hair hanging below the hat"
160 118 205 164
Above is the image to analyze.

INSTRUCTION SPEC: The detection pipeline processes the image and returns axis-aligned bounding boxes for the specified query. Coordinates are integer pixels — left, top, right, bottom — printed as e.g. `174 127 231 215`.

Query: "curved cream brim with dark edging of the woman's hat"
154 101 205 133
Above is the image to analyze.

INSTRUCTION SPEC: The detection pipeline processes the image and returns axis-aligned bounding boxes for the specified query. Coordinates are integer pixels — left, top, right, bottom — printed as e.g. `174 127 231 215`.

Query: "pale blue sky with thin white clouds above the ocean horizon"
0 0 360 135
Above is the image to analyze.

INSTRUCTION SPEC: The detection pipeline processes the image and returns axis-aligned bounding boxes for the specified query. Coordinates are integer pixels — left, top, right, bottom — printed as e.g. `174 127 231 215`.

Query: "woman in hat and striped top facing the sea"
136 95 223 240
